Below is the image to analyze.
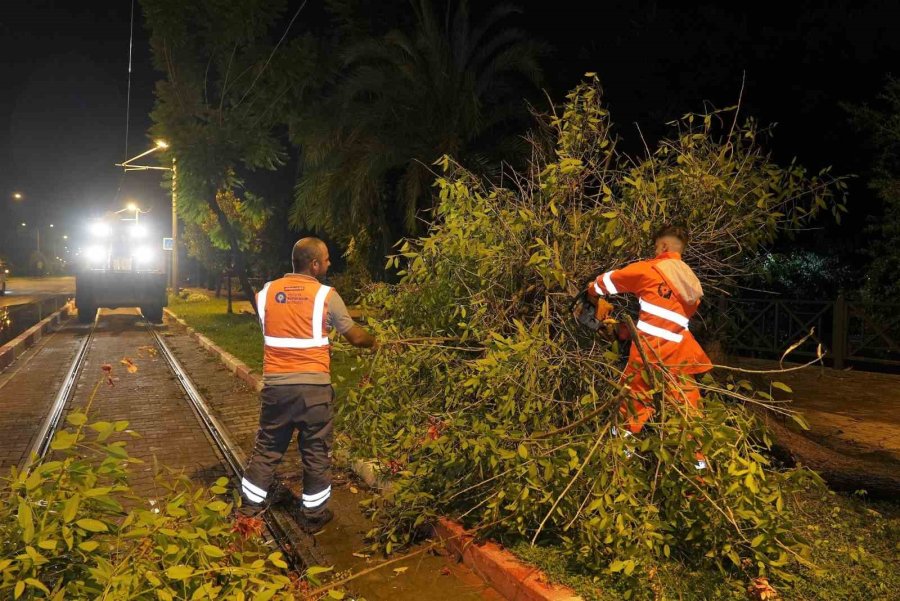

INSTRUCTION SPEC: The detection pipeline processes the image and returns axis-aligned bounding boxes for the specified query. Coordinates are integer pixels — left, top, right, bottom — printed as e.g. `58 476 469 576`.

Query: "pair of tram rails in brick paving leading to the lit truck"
20 312 330 573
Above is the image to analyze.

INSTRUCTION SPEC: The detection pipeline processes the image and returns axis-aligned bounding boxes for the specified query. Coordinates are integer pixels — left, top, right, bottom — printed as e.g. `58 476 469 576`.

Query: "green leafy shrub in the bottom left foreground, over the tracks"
0 413 295 601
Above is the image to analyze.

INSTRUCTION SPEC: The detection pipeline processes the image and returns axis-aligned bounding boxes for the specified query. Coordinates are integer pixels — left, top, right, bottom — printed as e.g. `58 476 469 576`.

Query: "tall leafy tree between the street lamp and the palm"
142 0 314 310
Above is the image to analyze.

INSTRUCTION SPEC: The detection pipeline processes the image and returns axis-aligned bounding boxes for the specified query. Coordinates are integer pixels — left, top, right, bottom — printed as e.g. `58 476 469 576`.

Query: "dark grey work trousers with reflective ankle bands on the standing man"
241 384 334 518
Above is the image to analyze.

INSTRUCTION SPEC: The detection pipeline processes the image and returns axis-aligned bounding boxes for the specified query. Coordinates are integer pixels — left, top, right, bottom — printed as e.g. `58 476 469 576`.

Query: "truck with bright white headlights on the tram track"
75 209 168 323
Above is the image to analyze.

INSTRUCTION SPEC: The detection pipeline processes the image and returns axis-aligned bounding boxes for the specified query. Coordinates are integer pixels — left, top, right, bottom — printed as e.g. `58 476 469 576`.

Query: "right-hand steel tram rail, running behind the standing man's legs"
145 320 331 572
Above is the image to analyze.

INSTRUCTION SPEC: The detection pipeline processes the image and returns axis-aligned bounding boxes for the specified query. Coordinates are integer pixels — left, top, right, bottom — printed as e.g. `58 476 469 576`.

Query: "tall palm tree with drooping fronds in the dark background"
290 0 544 268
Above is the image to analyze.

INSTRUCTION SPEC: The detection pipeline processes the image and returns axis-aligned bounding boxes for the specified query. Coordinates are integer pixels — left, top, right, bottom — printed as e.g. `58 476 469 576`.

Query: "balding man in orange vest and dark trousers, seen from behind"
241 238 377 532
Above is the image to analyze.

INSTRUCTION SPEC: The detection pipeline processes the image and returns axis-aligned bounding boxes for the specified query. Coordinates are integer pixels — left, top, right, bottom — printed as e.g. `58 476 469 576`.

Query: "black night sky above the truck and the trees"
0 0 900 268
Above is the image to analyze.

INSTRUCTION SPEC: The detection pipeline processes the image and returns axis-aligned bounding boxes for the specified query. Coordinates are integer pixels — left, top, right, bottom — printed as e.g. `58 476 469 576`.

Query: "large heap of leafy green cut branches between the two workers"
342 75 844 592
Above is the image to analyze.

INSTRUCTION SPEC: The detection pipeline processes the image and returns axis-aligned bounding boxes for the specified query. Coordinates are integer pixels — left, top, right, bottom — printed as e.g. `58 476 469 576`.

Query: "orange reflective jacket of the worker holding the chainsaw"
588 252 712 374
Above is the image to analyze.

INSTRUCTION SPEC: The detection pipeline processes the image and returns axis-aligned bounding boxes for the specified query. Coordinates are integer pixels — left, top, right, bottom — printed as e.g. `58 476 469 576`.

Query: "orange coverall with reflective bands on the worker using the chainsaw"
588 252 712 434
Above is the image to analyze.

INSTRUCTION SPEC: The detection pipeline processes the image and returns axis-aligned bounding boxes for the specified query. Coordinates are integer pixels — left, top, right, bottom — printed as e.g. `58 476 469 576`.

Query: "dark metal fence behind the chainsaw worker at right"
703 295 900 369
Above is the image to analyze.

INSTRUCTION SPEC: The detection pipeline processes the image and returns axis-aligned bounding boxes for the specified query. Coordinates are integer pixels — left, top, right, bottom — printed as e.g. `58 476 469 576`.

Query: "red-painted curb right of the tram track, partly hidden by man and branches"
165 309 581 601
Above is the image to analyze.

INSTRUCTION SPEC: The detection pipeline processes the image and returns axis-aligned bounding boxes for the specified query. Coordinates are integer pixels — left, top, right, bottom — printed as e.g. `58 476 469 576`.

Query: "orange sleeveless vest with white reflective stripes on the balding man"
256 274 332 374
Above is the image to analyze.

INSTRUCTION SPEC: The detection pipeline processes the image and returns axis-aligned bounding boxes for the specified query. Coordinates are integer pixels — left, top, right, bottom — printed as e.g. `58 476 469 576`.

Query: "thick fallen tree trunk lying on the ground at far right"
752 407 900 499
